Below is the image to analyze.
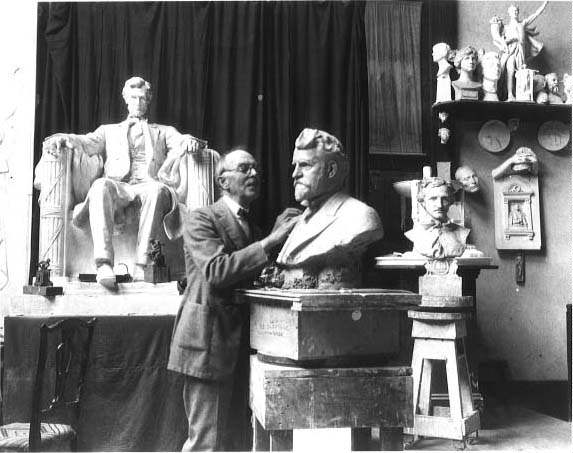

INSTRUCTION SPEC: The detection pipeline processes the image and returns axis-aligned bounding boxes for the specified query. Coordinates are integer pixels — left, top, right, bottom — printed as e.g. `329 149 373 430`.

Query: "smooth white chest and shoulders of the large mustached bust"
277 192 384 267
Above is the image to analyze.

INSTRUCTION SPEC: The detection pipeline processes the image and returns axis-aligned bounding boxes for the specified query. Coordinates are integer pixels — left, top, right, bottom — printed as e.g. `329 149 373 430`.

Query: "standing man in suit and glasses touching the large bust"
167 150 300 451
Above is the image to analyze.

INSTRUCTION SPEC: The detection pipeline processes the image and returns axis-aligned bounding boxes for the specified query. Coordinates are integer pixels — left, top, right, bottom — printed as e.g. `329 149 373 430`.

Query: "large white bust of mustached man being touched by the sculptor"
277 129 383 289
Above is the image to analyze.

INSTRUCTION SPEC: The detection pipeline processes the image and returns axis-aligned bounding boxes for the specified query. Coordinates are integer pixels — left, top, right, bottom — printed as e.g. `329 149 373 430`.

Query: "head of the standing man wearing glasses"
216 149 260 208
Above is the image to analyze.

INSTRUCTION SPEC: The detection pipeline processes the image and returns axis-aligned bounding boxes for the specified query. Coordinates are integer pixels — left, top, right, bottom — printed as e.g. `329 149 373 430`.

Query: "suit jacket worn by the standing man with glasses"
167 199 268 380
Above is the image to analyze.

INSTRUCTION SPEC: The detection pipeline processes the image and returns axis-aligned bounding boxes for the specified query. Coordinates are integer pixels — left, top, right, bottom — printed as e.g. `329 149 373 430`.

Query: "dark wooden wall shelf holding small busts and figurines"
432 100 571 124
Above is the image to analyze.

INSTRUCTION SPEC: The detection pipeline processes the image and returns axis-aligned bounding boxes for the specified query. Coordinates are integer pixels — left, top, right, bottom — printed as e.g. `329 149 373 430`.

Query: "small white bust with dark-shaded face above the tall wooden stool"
405 178 470 260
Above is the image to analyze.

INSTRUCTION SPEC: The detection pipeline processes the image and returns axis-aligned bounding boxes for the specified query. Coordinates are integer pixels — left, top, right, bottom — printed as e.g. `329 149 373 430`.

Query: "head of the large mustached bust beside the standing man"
292 128 348 206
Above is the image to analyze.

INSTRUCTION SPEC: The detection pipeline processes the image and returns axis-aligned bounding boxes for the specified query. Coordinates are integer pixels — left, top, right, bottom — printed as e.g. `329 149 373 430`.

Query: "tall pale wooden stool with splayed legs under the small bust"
407 311 480 447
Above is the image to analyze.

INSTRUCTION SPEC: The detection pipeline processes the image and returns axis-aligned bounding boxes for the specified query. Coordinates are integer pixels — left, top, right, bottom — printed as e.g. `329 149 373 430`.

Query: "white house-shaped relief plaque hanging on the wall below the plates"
491 147 541 250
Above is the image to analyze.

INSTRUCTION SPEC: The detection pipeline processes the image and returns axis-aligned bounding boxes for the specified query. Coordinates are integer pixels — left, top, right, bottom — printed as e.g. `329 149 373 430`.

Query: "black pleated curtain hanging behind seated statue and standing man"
33 2 368 237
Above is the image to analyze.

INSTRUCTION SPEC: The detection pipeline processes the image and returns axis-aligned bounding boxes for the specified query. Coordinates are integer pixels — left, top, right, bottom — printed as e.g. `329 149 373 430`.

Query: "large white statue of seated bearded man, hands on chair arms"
35 77 204 287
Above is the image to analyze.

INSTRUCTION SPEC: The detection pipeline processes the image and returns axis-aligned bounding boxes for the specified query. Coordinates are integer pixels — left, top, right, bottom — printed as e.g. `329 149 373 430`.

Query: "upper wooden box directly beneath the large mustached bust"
237 289 421 366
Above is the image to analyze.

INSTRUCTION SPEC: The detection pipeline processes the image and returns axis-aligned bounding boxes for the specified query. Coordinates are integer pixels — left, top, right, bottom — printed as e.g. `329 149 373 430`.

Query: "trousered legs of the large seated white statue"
87 177 172 265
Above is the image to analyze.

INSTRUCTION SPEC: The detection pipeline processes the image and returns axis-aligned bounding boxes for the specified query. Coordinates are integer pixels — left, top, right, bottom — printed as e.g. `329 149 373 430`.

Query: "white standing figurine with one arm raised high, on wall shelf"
490 1 548 101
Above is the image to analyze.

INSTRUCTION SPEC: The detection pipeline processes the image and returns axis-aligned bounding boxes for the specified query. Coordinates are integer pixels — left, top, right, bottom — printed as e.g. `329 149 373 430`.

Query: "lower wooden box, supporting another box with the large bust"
250 356 414 430
